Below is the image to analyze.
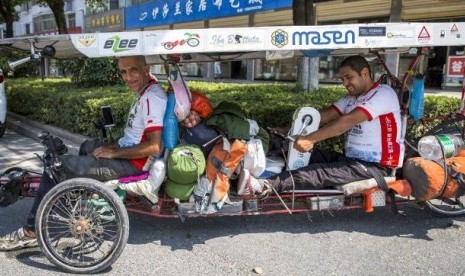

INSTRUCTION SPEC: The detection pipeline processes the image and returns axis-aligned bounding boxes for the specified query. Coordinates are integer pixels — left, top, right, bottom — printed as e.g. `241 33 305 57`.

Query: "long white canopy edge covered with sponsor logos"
71 22 465 58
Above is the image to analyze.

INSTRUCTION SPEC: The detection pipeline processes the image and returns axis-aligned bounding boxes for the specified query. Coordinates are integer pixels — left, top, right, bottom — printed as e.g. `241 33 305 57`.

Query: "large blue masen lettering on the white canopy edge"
292 30 355 45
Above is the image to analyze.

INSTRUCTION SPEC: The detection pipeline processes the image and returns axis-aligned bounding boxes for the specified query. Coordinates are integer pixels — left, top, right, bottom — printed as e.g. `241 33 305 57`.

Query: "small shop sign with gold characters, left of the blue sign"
84 9 124 33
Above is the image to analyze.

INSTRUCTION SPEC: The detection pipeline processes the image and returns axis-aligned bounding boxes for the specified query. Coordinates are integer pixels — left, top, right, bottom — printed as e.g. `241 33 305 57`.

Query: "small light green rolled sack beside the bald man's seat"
168 145 205 184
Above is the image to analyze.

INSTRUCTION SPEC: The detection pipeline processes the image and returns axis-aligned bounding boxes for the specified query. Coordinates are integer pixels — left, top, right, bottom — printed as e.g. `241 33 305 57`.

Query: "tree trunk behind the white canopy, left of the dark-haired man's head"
292 0 319 91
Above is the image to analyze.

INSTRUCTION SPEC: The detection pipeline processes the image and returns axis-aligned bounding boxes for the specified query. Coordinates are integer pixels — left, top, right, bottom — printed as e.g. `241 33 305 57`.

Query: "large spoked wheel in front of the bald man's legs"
35 178 129 273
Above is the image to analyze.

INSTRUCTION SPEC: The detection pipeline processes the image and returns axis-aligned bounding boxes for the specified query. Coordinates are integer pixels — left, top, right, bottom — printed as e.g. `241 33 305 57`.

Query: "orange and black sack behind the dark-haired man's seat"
402 156 465 201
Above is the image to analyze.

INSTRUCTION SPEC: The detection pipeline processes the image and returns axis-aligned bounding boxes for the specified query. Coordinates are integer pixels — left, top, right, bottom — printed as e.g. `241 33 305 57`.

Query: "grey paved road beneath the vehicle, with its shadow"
0 131 465 276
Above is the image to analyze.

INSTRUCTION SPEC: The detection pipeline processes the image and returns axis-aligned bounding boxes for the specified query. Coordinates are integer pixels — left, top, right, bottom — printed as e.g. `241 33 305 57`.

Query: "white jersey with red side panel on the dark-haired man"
333 83 404 168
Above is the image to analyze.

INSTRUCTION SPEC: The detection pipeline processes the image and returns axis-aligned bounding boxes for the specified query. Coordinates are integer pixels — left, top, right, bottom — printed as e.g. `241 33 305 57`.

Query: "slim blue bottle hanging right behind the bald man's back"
162 92 179 150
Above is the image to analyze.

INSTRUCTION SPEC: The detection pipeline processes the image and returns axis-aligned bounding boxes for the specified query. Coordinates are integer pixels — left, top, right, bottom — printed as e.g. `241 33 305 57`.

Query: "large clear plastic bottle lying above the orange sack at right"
418 134 464 160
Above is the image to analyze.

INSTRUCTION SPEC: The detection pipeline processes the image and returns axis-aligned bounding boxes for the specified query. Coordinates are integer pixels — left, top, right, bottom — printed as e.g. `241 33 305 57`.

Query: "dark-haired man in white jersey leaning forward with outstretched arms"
243 56 404 193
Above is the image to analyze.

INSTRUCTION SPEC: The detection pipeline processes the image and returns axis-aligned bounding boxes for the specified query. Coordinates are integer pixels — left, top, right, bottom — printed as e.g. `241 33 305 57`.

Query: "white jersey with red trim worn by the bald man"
118 80 167 169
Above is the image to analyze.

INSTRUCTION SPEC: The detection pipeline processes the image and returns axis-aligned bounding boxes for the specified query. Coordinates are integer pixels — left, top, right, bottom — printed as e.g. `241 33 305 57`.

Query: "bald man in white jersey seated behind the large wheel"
0 56 167 251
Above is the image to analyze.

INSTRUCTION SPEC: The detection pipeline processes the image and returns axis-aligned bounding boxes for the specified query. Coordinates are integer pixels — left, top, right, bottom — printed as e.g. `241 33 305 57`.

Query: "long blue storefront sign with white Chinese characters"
124 0 292 29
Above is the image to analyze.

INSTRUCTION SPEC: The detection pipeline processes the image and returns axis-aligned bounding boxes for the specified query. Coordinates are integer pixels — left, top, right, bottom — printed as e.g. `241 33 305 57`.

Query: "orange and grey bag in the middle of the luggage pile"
207 139 247 203
